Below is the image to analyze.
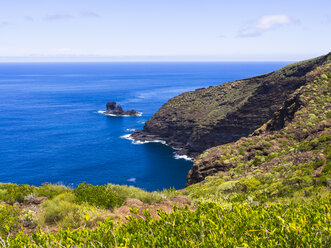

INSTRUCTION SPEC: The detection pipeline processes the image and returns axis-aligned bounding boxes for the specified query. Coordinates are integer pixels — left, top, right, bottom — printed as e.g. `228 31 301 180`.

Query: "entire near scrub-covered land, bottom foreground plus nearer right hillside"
0 55 331 248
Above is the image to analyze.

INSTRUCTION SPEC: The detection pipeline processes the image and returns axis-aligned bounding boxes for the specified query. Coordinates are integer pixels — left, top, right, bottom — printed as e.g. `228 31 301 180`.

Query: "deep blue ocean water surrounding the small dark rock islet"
0 62 287 190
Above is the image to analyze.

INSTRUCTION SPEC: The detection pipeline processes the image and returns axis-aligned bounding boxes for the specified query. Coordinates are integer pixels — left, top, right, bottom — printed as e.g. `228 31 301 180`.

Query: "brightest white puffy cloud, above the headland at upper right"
238 15 294 38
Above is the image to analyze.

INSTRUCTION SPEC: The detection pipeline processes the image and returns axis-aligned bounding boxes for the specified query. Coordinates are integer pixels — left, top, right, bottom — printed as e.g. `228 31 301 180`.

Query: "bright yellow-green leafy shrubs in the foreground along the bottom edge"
3 198 331 247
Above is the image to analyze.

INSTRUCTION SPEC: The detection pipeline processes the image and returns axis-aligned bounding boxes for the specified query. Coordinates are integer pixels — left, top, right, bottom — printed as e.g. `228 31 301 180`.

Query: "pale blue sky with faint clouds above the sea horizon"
0 0 331 62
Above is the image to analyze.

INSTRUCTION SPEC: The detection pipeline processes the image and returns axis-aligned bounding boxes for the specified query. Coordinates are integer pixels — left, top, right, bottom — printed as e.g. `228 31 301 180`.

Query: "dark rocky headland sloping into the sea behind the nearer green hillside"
132 52 328 157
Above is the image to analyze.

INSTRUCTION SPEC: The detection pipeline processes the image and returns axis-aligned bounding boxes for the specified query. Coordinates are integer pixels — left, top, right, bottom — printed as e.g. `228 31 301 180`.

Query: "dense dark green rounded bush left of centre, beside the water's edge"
73 182 124 209
